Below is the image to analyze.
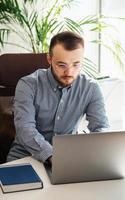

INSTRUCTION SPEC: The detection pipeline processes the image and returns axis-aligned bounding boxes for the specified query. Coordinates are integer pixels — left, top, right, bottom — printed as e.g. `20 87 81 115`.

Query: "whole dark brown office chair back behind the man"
0 53 49 164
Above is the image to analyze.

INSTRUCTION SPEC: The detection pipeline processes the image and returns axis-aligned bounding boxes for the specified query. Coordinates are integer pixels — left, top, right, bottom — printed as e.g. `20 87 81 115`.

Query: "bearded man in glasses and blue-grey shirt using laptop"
8 32 109 162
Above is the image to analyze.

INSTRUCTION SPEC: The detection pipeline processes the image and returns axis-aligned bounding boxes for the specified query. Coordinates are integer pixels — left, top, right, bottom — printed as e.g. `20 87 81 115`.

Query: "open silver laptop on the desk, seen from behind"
45 132 125 184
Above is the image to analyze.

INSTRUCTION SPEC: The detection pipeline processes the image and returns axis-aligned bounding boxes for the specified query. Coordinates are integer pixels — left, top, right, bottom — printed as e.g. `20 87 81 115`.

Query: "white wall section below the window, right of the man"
100 78 125 130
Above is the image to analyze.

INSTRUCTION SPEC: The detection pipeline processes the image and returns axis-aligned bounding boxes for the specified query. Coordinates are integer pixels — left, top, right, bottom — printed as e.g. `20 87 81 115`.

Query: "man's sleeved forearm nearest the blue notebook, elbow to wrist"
16 127 53 162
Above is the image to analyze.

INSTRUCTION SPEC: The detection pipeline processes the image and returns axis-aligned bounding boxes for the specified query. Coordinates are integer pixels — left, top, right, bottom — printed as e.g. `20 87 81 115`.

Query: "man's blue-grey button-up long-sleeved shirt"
8 68 109 162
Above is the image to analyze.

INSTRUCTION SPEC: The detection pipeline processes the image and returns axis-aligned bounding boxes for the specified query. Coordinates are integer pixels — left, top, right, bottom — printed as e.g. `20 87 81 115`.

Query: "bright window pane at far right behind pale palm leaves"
100 0 125 77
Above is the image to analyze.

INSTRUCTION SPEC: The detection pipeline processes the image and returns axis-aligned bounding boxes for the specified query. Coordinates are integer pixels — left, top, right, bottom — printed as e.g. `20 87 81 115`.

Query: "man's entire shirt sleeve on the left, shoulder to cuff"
14 79 53 162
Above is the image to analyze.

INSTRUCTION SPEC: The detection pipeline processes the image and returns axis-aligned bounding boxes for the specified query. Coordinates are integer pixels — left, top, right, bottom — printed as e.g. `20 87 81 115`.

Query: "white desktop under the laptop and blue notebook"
0 157 125 200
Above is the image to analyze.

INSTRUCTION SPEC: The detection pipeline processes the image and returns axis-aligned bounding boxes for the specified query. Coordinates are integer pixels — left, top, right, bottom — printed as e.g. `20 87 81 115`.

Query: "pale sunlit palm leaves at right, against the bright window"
92 15 125 74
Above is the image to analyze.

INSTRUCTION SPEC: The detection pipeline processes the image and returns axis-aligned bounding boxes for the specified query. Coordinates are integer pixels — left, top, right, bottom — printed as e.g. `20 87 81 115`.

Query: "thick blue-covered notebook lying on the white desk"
0 163 43 193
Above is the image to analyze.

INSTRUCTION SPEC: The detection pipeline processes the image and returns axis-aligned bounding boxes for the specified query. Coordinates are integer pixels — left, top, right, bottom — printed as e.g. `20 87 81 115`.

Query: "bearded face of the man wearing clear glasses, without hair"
48 44 83 87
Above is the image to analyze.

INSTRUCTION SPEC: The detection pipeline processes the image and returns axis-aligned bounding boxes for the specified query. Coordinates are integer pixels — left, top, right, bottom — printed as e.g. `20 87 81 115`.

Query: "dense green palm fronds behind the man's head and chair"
0 0 83 53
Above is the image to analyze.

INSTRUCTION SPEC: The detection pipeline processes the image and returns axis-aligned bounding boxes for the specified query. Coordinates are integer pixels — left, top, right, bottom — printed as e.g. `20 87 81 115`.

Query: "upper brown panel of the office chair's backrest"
0 53 49 96
